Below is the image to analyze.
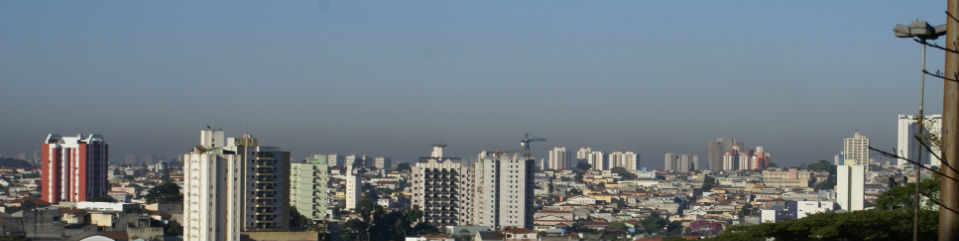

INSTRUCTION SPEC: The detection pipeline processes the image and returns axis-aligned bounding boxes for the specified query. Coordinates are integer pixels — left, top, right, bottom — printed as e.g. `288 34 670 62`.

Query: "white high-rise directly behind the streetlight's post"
896 114 942 169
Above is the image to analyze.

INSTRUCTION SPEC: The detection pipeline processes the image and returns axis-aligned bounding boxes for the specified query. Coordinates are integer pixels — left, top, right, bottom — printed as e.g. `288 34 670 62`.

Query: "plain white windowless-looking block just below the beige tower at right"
836 164 866 211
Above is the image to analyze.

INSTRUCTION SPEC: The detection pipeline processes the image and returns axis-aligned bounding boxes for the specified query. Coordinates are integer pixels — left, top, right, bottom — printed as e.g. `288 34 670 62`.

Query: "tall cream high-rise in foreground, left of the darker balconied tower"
182 129 244 241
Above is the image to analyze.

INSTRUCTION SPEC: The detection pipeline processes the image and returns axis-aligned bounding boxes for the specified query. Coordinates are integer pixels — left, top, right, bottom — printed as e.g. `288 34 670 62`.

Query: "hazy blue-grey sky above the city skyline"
0 0 946 168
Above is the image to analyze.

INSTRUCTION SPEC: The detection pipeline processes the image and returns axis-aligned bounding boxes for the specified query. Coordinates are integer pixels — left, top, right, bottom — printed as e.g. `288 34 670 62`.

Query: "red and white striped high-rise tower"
40 133 109 203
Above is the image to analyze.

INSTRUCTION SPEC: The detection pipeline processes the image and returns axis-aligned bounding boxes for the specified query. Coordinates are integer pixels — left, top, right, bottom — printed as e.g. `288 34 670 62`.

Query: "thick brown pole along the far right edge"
939 0 959 240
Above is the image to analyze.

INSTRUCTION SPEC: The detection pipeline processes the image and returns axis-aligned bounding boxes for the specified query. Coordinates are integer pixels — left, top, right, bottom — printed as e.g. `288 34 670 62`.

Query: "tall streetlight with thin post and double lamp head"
892 20 946 241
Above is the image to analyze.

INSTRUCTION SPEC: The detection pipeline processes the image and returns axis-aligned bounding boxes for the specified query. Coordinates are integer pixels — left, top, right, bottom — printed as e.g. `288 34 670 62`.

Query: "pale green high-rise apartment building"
290 155 330 220
